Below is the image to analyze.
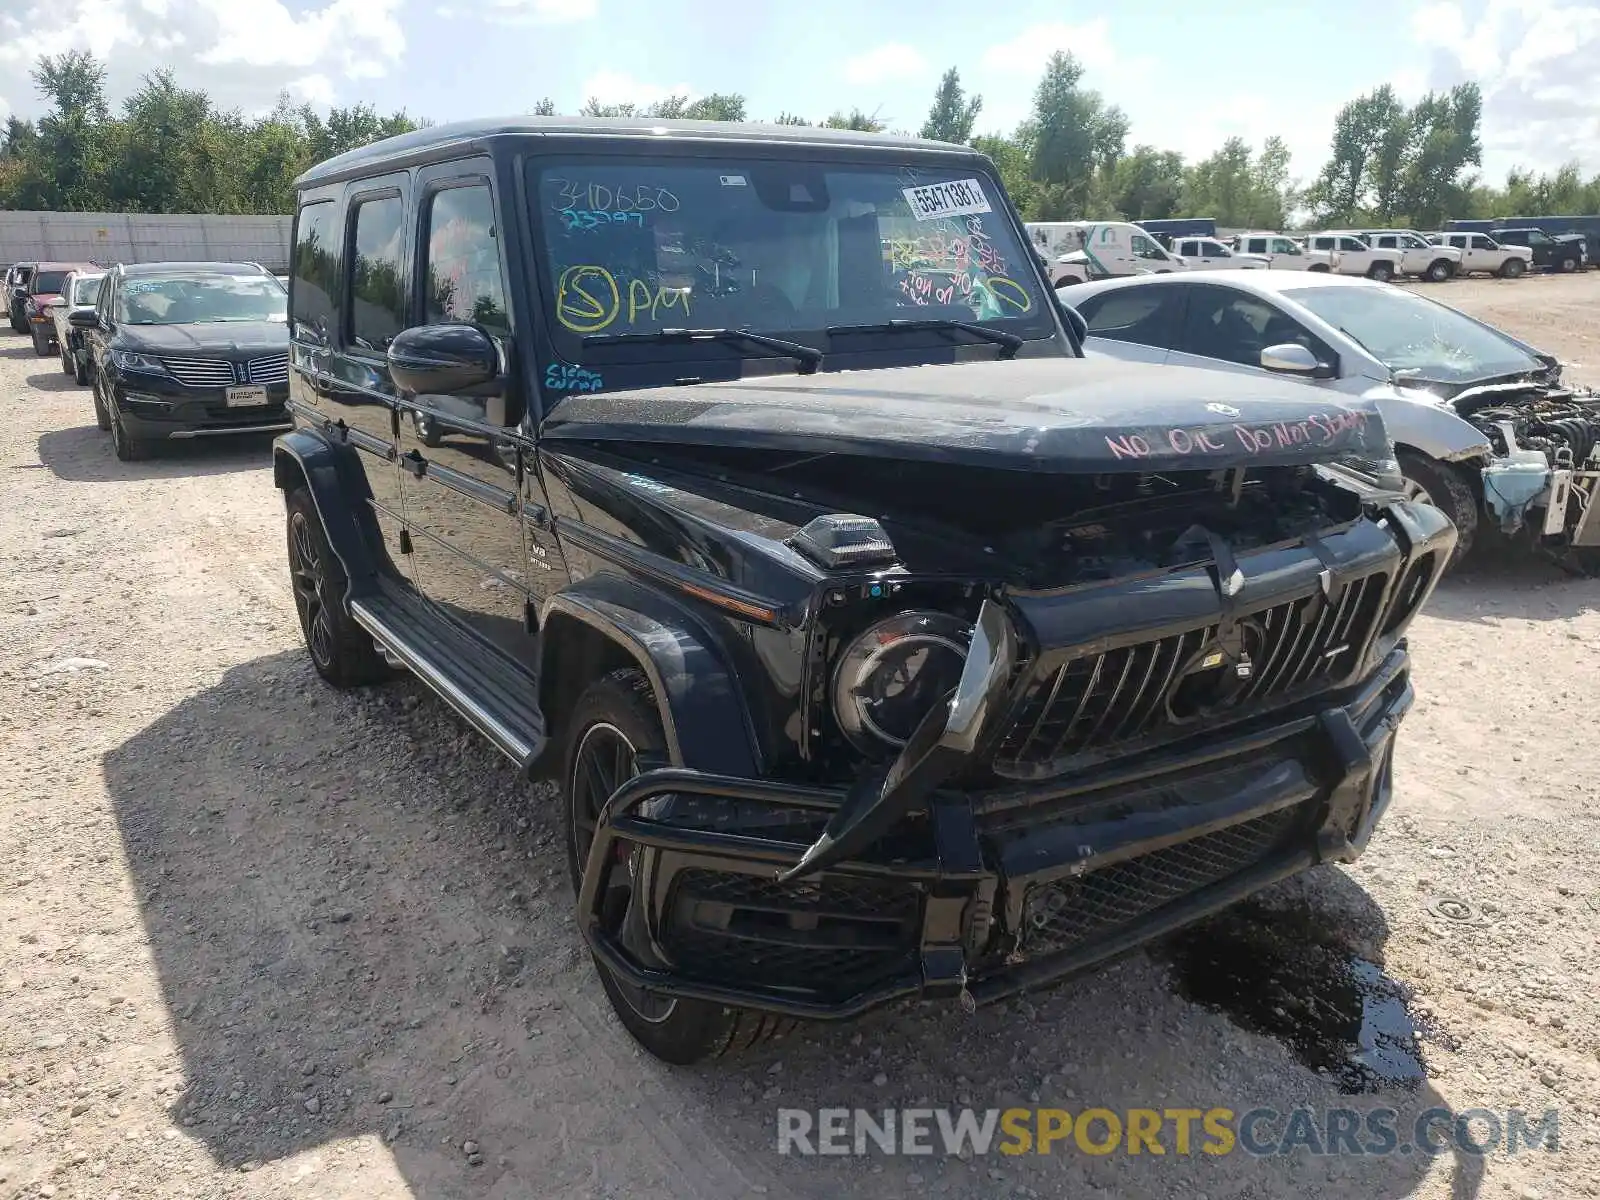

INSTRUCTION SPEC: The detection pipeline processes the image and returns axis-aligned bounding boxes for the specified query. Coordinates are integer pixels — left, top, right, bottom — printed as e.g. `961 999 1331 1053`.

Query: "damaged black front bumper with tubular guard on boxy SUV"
579 645 1413 1019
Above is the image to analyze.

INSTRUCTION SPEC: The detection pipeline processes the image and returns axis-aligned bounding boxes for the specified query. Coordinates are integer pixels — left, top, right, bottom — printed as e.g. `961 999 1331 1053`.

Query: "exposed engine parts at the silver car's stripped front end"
1450 381 1600 549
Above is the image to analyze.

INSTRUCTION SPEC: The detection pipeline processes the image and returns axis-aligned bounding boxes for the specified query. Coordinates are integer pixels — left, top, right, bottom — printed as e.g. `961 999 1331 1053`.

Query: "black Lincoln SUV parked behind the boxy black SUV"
67 262 290 461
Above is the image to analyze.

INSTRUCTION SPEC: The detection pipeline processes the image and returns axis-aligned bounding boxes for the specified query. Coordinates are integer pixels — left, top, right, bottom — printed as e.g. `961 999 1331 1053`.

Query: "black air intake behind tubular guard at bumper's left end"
662 870 922 997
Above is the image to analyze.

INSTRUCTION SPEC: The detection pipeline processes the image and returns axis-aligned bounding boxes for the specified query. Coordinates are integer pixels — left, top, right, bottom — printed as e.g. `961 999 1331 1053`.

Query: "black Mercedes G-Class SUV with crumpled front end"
275 118 1454 1062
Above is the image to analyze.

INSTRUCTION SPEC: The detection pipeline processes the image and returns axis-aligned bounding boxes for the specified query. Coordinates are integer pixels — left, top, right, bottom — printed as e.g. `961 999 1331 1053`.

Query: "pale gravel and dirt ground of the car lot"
0 274 1600 1200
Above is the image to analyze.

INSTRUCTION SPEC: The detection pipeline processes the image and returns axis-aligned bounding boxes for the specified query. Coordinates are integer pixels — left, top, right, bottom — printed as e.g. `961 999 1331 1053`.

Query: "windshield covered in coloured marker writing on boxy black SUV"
533 158 1054 363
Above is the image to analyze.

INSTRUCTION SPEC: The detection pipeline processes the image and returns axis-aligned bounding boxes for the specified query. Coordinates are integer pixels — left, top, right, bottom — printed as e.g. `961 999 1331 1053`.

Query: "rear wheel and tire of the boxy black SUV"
285 488 392 688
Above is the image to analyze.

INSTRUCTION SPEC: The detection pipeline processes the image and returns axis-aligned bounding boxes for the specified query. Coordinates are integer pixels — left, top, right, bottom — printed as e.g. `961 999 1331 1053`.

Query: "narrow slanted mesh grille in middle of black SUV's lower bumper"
1021 806 1299 955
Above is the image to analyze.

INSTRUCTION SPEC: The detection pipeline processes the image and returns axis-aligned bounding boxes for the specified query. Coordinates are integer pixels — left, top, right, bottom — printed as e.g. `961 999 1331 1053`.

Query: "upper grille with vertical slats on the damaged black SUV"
994 574 1387 778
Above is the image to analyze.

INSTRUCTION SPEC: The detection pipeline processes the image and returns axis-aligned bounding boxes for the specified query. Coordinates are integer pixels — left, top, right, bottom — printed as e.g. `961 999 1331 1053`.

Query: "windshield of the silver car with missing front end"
1290 288 1542 382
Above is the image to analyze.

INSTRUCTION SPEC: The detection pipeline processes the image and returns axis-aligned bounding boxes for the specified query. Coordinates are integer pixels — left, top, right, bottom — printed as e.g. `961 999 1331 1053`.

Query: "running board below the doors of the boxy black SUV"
350 590 546 771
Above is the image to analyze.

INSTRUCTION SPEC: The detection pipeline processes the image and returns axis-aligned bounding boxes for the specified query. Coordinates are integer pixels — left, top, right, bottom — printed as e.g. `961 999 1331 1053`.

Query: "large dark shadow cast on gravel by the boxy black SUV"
102 653 1482 1200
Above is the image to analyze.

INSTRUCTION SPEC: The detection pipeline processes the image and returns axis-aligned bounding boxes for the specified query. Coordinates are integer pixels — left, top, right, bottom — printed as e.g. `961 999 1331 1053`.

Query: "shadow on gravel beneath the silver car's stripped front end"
1422 546 1600 624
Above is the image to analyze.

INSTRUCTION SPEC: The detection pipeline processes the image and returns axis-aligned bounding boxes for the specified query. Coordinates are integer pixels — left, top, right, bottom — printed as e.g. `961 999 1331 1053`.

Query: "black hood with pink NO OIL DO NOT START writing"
544 357 1389 472
